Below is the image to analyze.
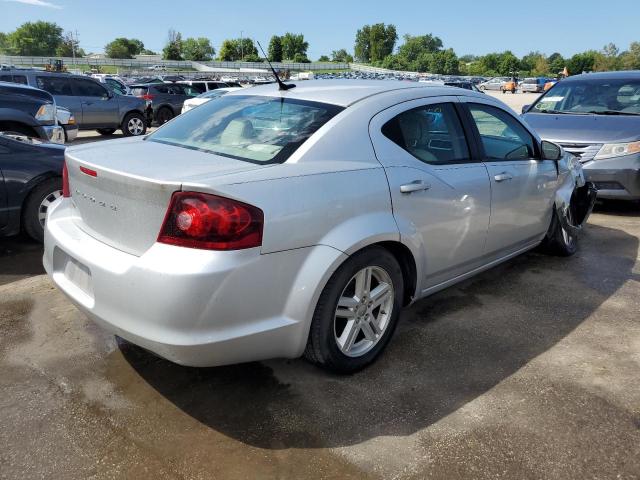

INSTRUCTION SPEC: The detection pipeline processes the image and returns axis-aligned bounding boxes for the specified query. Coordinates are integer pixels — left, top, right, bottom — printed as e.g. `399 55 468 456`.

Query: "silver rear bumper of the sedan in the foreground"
43 199 346 366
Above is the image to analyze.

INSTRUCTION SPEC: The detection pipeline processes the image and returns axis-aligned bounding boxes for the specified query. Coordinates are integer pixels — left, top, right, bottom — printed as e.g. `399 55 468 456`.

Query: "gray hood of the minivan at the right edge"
522 113 640 143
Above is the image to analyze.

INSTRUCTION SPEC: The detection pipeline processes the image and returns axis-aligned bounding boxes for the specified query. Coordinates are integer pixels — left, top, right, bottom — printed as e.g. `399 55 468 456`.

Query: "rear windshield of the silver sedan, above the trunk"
147 95 343 163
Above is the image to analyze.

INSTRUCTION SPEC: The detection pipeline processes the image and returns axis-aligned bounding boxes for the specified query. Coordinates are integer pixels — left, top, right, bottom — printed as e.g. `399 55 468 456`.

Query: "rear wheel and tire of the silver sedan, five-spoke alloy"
304 247 404 374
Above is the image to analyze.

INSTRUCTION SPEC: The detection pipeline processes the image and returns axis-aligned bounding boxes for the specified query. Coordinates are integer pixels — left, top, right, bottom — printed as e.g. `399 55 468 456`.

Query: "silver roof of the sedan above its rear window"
222 80 472 107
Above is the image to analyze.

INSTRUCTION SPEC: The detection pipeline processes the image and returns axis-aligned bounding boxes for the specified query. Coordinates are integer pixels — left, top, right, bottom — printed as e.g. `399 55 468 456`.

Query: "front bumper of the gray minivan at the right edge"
583 155 640 200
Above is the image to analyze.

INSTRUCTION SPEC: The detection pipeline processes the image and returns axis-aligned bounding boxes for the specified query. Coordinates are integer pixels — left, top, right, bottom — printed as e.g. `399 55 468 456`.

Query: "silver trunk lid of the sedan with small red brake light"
65 138 261 256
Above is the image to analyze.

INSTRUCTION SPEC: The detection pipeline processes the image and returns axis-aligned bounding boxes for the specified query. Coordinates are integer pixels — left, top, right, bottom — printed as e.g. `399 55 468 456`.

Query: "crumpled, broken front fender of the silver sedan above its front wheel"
555 152 598 236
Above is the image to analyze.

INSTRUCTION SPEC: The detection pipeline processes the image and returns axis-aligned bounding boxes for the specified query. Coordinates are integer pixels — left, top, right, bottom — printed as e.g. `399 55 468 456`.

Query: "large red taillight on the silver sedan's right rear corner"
158 192 264 250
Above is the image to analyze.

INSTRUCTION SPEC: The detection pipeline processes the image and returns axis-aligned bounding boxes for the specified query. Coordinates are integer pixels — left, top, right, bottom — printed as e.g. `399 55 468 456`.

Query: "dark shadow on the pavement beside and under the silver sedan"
119 220 638 449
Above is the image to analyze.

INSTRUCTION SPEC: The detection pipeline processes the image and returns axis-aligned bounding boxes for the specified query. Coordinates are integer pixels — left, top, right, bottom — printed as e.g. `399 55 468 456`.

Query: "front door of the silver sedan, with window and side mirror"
465 99 558 257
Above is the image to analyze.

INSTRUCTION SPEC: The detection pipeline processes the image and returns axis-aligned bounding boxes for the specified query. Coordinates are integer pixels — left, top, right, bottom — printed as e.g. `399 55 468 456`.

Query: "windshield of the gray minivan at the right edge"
530 80 640 115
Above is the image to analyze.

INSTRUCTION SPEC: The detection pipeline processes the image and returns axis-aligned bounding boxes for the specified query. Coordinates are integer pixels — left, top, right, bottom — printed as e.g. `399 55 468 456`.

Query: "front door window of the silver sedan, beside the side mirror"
469 104 535 160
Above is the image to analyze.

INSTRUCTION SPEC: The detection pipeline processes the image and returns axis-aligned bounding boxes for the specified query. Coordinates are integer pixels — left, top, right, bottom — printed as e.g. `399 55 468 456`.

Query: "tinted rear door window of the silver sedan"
382 103 469 164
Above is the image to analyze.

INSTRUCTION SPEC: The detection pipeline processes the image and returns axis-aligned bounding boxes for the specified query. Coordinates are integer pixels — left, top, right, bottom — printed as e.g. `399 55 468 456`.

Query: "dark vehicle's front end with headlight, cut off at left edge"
0 82 64 143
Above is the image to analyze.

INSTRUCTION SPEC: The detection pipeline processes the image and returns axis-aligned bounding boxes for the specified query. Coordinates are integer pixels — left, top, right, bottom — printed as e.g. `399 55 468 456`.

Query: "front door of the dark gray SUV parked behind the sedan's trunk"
71 78 119 128
